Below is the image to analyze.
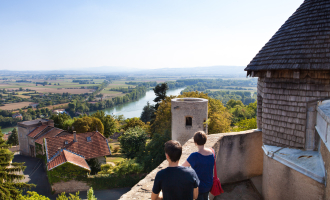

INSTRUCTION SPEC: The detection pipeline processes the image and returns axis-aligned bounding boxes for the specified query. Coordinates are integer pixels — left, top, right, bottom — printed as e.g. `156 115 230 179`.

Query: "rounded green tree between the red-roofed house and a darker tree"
119 126 148 158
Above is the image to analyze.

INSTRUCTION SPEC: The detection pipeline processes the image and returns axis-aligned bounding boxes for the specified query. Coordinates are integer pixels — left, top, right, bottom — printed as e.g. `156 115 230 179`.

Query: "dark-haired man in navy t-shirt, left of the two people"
151 140 199 200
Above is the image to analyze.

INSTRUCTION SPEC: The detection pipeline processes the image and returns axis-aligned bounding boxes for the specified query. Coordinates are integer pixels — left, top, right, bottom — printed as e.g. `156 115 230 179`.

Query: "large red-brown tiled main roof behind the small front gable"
46 132 111 159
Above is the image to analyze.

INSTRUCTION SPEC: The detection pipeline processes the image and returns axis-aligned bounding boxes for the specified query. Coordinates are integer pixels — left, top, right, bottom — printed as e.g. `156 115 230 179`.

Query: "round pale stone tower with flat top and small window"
171 98 208 145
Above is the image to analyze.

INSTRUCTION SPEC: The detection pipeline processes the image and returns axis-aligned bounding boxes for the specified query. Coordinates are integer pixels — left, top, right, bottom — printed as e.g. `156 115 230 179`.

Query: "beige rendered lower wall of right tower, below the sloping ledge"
262 155 325 200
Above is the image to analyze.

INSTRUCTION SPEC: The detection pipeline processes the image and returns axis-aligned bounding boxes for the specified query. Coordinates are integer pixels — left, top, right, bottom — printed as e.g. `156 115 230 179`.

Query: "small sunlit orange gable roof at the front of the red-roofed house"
47 149 91 171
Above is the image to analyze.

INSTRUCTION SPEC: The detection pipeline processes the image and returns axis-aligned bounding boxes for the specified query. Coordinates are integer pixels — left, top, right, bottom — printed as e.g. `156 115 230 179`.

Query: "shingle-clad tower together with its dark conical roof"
245 0 330 150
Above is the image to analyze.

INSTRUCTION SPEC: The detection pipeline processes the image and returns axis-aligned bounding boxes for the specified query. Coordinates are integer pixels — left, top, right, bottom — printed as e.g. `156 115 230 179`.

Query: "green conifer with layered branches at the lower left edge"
0 129 34 200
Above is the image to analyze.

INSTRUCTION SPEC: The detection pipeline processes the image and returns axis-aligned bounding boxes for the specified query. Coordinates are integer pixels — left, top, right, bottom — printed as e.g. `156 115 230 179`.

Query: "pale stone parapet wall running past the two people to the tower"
120 130 263 200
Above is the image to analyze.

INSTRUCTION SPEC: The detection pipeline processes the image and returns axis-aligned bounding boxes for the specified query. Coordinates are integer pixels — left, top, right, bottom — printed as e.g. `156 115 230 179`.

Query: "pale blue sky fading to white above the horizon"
0 0 303 70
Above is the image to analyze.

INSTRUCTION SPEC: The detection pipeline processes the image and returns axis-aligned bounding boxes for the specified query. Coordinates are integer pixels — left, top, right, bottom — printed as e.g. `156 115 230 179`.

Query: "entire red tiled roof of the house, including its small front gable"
44 131 111 171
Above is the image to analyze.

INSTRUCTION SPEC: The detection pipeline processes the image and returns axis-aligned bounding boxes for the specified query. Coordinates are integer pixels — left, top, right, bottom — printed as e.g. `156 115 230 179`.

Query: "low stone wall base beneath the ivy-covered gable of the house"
52 180 90 194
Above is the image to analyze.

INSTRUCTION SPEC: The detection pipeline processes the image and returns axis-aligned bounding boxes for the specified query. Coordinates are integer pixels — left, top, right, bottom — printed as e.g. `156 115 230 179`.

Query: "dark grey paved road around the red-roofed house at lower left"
13 155 130 200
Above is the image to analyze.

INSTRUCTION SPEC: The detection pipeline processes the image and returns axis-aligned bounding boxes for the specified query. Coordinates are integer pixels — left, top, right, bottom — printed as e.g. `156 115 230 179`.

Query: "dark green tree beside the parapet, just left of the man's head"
136 131 171 173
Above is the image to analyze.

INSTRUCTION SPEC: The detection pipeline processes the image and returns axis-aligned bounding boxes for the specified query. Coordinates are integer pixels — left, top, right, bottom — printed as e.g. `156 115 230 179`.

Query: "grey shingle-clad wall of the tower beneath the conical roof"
254 71 330 150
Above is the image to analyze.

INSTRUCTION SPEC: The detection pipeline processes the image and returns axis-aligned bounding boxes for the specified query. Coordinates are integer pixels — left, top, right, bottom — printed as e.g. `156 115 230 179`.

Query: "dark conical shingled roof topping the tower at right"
245 0 330 74
